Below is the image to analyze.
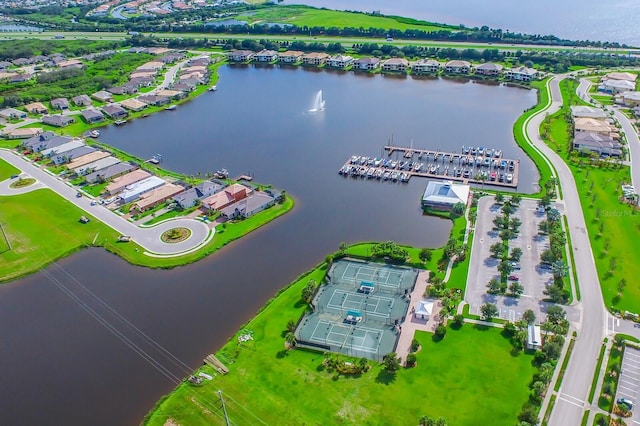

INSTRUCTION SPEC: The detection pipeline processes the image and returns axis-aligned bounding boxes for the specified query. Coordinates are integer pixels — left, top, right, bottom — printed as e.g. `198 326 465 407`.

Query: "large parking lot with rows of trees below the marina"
465 196 553 321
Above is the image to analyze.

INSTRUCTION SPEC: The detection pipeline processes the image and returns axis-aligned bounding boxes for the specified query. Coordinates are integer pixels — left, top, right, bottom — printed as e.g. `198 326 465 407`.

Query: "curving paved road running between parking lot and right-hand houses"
525 75 608 426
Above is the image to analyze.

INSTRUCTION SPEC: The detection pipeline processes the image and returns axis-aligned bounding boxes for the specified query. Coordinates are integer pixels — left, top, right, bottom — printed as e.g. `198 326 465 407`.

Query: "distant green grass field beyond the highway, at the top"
235 5 459 31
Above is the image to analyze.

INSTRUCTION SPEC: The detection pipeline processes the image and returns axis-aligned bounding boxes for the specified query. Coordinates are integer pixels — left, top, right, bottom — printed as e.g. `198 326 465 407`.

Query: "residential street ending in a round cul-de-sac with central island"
0 149 209 255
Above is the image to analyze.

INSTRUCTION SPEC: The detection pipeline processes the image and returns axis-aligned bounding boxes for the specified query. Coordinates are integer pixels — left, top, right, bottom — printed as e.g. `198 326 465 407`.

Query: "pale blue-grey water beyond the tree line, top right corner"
284 0 640 46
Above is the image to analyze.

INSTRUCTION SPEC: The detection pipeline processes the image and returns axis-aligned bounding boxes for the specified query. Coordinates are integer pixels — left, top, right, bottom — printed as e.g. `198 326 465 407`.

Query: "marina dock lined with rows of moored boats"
339 145 520 188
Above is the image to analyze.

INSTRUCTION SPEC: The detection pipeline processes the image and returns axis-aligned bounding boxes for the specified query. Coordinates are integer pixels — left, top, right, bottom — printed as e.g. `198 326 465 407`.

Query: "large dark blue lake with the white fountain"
0 66 537 425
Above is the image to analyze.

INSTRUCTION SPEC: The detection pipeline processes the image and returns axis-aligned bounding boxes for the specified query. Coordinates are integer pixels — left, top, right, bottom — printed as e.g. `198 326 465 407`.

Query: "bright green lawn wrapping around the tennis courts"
145 265 534 425
